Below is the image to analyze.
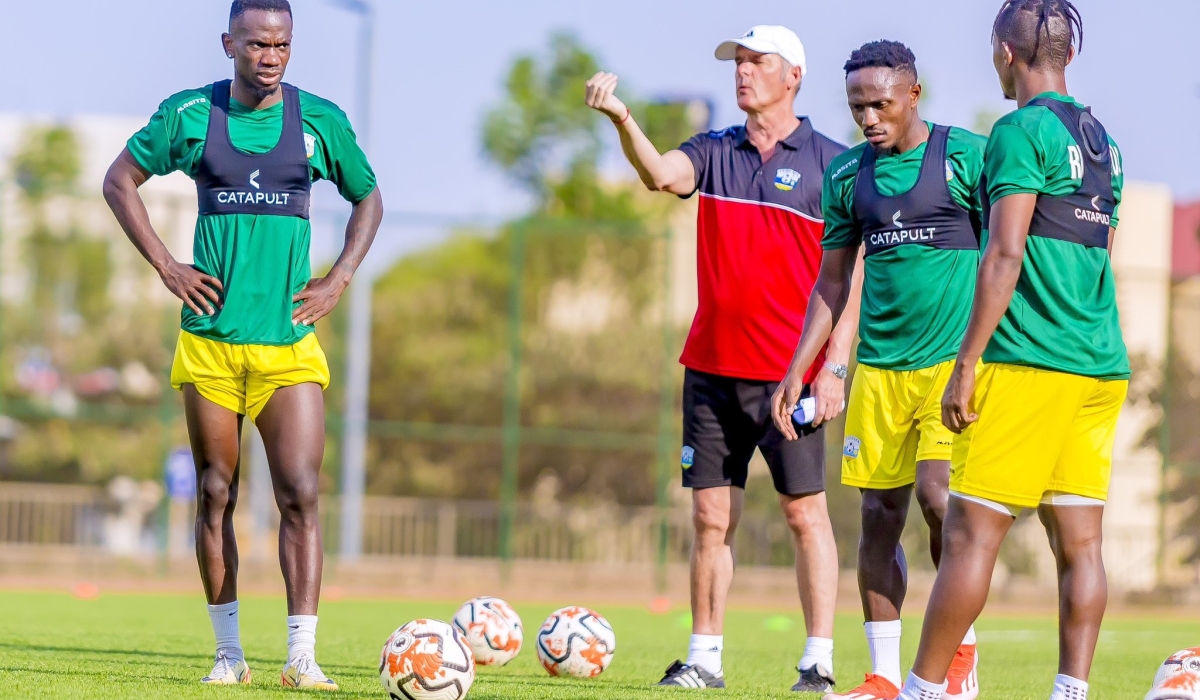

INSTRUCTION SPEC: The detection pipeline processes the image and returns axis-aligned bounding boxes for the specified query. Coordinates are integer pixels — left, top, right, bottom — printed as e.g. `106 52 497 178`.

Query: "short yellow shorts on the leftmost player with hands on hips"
170 331 329 420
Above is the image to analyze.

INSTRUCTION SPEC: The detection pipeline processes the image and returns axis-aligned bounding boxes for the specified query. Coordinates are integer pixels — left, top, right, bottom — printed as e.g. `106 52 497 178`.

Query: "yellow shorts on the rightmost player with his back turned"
950 364 1129 508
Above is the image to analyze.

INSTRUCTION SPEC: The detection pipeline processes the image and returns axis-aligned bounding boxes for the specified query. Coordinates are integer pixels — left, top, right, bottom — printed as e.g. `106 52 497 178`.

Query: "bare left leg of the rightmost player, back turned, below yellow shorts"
912 498 1013 683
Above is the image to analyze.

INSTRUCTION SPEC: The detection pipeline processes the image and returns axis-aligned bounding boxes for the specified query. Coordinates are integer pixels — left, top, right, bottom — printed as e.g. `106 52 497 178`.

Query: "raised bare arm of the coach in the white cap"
586 72 696 196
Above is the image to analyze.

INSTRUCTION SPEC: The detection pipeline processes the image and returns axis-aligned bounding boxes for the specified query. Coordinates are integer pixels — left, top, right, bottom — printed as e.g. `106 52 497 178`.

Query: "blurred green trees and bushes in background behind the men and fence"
0 34 1200 572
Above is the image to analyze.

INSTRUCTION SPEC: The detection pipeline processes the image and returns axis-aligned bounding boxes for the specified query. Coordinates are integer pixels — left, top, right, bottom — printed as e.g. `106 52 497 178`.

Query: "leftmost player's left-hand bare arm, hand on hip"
104 149 224 316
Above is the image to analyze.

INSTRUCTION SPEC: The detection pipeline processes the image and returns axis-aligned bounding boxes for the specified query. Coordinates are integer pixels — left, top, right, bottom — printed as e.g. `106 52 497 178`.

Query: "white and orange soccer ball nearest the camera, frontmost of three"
379 620 475 700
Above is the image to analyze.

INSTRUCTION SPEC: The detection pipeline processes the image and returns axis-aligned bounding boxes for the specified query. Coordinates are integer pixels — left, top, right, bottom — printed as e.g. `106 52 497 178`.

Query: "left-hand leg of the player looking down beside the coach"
858 485 913 622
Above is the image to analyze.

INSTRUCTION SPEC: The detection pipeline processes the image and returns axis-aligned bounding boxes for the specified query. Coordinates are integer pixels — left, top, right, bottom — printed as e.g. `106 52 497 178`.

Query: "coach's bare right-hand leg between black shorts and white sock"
779 491 838 639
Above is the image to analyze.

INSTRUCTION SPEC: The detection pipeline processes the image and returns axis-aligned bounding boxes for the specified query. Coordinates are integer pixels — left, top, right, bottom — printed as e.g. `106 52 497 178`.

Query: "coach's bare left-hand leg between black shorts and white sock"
691 486 745 634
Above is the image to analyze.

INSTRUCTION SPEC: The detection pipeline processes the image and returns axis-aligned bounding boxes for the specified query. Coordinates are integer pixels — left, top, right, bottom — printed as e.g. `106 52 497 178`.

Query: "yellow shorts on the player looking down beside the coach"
841 360 954 489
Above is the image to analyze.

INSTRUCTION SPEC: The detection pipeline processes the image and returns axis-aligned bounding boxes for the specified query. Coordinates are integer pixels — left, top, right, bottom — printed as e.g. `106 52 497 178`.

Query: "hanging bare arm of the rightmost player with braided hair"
942 195 1038 432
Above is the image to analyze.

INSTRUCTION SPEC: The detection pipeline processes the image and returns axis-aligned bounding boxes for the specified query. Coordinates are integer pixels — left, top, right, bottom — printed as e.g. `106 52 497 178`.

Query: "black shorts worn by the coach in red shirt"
680 370 826 496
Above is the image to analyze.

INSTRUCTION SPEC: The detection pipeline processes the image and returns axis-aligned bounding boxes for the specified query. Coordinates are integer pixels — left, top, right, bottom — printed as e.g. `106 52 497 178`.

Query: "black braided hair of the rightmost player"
991 0 1084 68
